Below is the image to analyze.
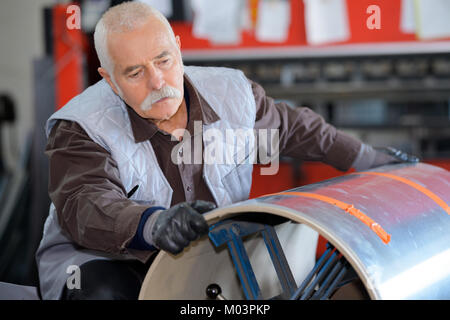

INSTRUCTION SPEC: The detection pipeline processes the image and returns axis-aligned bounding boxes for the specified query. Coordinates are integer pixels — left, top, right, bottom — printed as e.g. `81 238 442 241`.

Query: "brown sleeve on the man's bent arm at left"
45 120 153 261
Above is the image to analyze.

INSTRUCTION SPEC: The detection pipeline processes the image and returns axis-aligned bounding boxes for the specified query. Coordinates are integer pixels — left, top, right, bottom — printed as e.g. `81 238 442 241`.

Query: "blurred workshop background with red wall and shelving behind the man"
0 0 450 286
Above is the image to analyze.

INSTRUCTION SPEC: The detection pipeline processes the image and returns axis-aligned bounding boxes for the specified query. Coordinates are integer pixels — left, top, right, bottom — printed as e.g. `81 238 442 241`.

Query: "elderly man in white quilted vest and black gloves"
36 2 418 299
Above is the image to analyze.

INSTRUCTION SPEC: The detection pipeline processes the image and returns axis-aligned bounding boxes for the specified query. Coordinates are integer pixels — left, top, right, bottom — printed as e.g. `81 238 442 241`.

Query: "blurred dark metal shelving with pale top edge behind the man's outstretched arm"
183 49 450 157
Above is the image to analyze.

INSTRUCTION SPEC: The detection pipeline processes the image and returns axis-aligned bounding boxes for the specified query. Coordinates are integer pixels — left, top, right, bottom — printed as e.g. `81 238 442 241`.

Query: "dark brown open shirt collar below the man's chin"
126 74 220 143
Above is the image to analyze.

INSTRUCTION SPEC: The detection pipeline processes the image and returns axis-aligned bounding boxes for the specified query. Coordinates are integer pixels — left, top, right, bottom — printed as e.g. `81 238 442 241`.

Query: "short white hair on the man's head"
94 1 175 74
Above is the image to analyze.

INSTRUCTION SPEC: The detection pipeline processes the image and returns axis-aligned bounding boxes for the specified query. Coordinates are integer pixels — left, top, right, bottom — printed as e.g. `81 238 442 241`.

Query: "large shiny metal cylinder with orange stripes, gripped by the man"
140 163 450 299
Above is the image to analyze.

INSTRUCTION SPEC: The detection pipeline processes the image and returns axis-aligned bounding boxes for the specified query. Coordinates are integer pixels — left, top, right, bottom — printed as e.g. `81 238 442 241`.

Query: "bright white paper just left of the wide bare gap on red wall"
303 0 350 45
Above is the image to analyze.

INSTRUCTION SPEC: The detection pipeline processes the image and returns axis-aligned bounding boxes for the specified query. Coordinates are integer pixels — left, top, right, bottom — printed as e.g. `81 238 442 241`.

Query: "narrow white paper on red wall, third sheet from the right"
255 0 291 42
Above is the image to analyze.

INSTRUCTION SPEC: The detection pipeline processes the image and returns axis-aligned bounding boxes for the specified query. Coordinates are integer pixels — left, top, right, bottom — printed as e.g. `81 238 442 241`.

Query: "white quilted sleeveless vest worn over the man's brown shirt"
36 66 256 299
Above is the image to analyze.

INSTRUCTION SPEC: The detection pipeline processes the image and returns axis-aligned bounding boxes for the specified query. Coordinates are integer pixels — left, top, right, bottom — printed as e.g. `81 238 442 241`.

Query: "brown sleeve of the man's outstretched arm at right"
250 81 362 171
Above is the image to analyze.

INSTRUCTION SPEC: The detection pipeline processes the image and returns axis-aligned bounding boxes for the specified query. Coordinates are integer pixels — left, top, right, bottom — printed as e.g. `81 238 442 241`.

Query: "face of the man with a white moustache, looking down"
99 19 184 121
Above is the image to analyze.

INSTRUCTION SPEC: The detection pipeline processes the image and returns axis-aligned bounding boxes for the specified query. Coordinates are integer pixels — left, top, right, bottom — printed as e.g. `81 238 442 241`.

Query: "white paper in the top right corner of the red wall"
415 0 450 39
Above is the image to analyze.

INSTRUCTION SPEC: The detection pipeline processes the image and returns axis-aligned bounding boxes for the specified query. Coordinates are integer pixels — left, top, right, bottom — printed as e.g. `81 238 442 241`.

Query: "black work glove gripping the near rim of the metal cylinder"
151 200 216 254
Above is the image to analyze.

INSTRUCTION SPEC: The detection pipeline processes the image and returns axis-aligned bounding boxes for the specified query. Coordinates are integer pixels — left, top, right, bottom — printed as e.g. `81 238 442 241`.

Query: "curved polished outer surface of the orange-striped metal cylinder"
212 163 450 299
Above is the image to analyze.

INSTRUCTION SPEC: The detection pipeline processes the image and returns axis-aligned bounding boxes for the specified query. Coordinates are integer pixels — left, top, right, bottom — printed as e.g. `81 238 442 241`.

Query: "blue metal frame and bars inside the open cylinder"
209 220 351 300
